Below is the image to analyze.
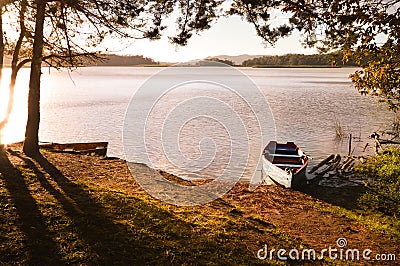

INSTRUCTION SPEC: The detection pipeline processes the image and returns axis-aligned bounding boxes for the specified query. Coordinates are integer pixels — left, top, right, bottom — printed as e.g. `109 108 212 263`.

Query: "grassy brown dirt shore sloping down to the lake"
0 145 400 265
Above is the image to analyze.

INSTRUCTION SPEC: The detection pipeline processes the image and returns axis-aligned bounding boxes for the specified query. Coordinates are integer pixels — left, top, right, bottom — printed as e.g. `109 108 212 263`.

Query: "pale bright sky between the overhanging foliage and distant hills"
110 17 316 62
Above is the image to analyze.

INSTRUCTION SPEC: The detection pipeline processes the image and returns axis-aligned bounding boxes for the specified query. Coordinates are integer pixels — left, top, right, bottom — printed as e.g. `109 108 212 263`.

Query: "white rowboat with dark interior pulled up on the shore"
262 141 308 188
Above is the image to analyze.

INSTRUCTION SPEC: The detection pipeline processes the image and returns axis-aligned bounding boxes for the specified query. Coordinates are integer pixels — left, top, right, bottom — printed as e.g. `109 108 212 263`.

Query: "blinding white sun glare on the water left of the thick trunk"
0 68 29 144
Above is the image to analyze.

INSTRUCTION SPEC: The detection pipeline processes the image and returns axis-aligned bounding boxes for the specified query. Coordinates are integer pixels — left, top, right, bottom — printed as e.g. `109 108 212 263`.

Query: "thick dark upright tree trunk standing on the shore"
23 0 46 156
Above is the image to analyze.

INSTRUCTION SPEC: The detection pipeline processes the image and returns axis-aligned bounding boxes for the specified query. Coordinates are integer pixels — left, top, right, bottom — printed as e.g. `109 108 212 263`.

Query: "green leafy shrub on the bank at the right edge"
355 147 400 217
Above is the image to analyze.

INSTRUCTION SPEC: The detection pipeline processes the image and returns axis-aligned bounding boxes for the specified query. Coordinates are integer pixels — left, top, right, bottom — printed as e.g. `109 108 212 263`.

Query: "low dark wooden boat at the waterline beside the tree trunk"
40 142 108 156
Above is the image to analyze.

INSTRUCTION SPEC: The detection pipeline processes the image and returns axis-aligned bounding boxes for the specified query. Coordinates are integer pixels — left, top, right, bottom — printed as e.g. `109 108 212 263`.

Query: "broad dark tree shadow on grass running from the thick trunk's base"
7 152 173 265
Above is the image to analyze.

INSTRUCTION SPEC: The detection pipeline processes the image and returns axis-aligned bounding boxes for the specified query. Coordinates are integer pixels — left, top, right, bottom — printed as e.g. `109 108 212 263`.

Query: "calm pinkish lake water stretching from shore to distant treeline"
0 67 393 181
